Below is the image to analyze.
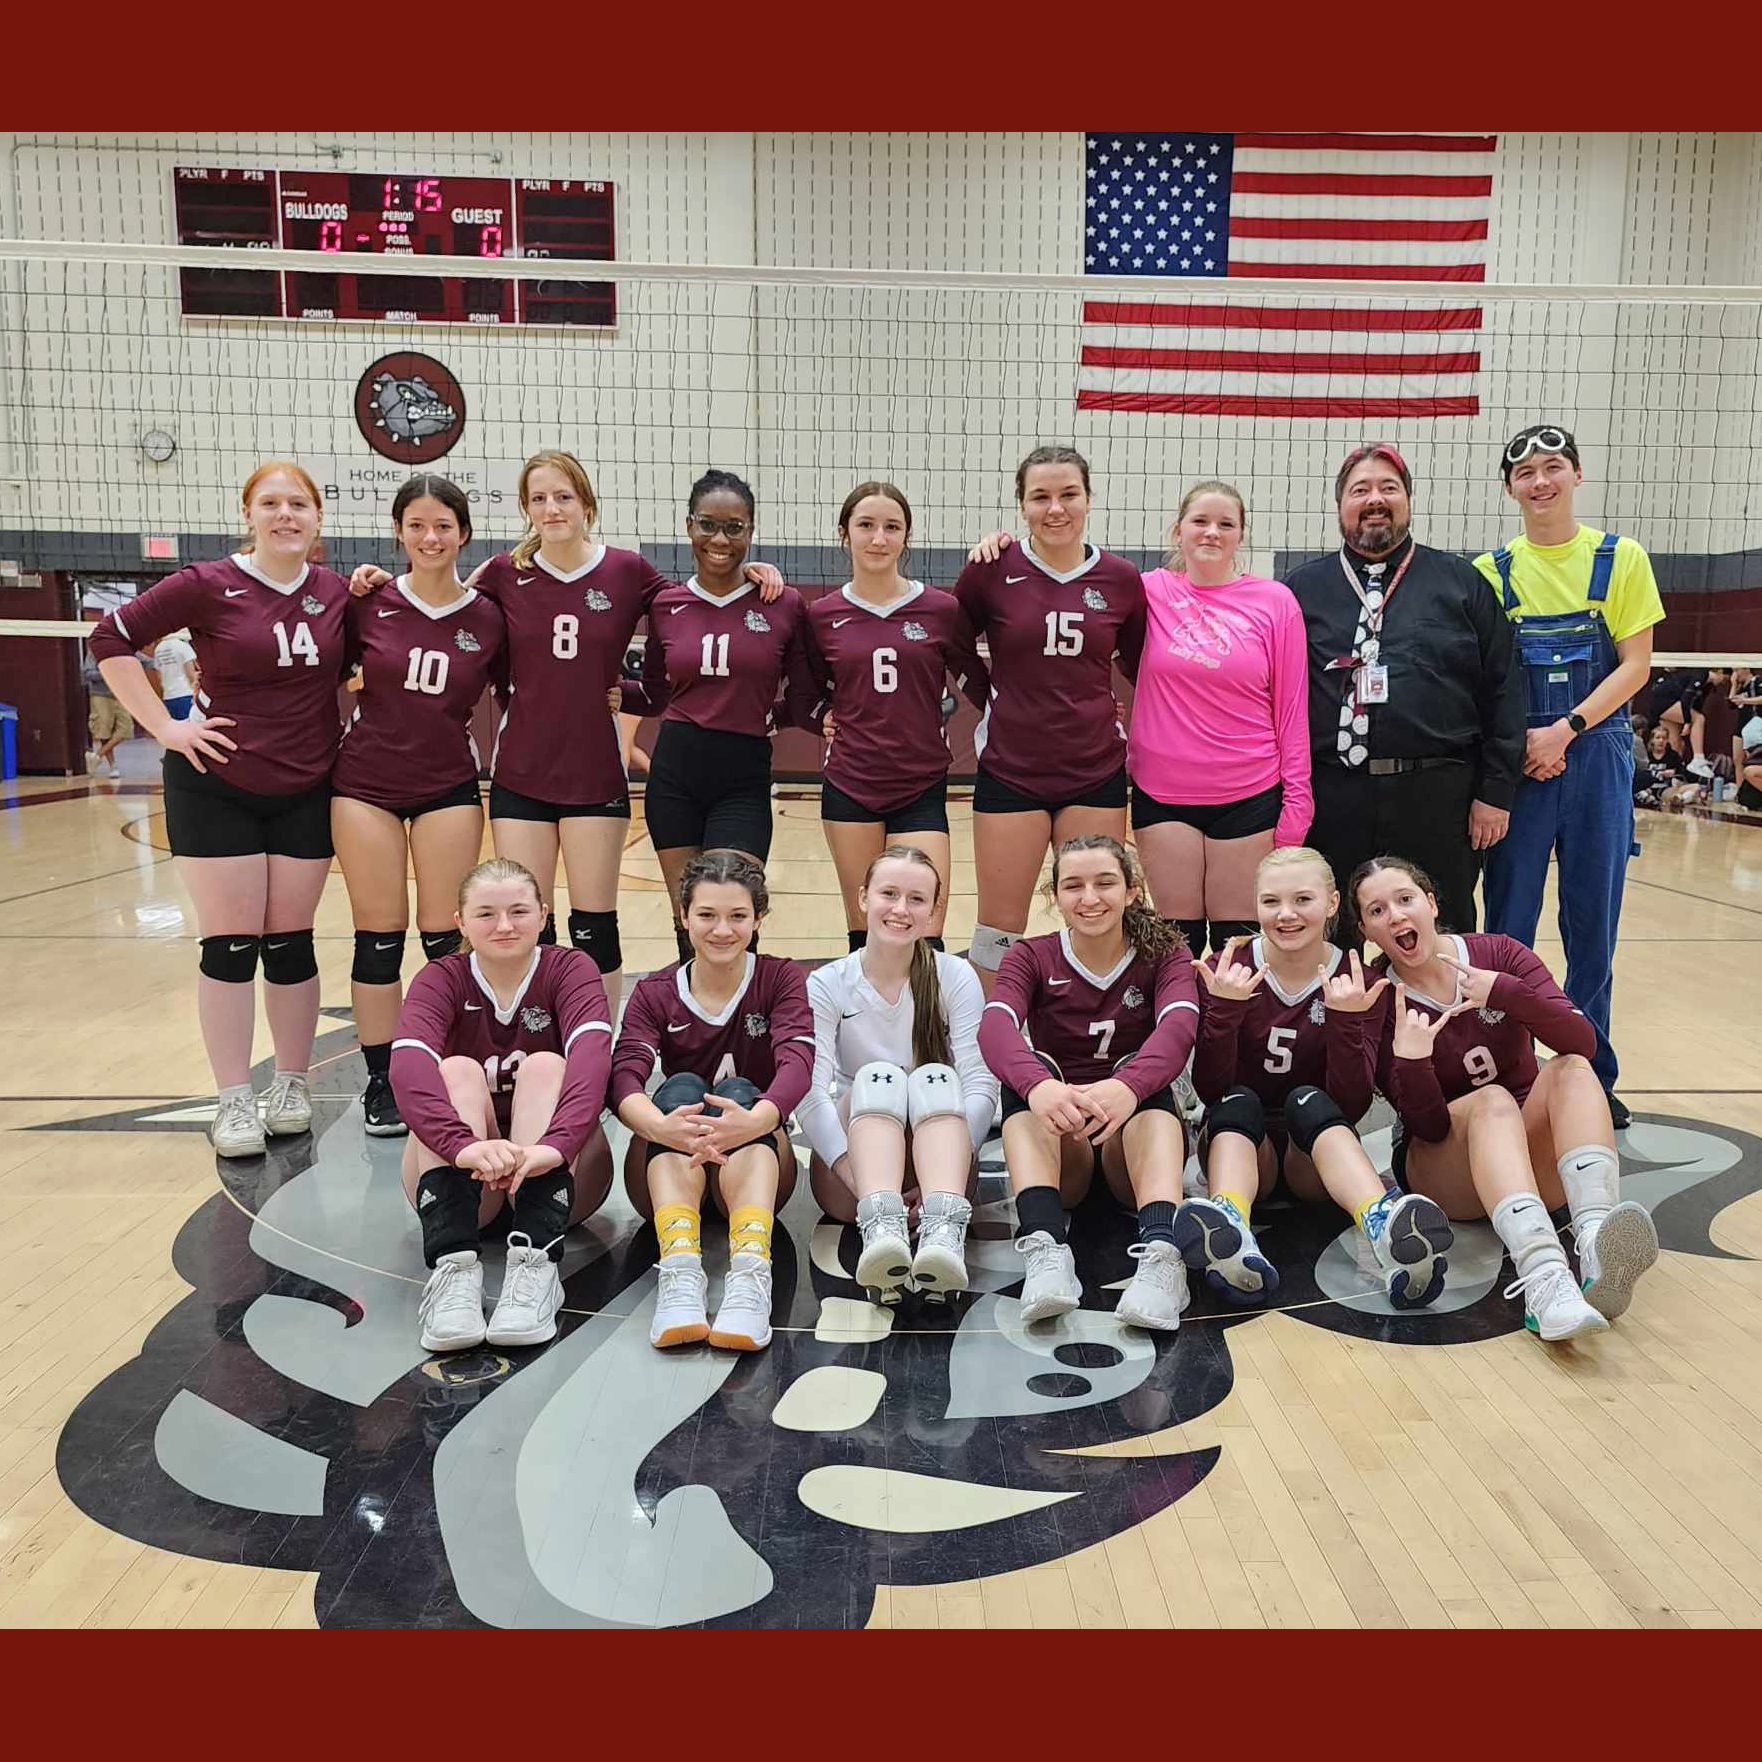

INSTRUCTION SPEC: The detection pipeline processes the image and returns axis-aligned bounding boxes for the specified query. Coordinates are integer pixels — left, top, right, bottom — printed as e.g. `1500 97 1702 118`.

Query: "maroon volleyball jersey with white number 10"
331 574 506 811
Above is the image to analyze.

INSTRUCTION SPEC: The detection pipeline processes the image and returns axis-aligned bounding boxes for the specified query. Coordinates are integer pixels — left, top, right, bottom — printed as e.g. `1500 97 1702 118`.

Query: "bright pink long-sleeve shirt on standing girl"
1126 569 1314 844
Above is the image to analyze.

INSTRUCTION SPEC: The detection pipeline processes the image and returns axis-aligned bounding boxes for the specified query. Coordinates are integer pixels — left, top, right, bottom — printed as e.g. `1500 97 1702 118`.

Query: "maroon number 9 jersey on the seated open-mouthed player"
1374 936 1596 1144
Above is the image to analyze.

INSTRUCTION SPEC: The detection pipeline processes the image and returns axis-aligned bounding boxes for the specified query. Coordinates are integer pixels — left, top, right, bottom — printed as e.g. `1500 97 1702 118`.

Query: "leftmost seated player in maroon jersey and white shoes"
391 856 611 1351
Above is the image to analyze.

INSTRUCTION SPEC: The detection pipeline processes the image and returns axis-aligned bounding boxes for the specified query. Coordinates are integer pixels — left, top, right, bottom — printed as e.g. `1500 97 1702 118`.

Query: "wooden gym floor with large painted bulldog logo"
0 751 1762 1628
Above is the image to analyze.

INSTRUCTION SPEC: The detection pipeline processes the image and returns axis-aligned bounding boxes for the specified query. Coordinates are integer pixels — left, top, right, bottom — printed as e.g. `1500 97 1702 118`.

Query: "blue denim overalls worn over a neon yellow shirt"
1482 532 1633 1089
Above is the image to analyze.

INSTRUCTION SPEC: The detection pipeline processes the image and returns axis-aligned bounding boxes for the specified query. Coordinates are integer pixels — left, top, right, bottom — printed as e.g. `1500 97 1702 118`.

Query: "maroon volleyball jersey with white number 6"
807 581 990 814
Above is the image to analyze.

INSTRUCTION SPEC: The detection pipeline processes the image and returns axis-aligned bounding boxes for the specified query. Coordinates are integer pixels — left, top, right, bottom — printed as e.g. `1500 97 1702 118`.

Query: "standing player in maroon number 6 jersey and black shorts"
807 481 990 951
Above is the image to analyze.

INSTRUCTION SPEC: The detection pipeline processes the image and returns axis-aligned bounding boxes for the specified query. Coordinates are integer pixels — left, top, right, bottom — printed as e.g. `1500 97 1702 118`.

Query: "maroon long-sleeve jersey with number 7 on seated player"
980 930 1200 1101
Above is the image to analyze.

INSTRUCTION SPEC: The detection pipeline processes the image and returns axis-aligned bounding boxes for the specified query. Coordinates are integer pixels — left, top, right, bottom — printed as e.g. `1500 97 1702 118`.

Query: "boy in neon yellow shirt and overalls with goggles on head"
1475 423 1663 1129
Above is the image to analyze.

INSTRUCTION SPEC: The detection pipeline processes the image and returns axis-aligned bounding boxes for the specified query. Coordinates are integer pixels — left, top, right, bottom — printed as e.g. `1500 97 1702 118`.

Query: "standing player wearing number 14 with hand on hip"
90 460 349 1156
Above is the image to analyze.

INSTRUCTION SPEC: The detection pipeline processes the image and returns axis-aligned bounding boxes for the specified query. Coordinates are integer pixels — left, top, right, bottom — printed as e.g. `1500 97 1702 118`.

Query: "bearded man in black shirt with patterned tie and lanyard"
1288 442 1524 934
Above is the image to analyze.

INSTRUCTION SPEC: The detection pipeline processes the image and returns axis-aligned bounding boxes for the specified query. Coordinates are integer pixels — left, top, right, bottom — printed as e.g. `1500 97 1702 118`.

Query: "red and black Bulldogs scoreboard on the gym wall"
171 166 617 324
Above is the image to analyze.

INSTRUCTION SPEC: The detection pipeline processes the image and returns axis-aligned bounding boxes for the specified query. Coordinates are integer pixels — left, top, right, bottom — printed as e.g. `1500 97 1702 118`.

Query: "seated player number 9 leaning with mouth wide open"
1351 856 1658 1339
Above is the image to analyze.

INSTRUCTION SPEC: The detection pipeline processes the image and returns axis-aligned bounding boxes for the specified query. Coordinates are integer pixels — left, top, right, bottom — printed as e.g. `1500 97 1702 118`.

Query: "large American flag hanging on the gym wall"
1077 130 1498 418
